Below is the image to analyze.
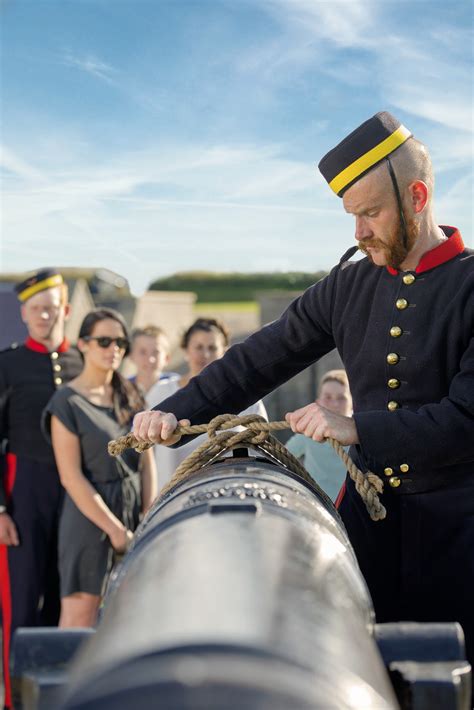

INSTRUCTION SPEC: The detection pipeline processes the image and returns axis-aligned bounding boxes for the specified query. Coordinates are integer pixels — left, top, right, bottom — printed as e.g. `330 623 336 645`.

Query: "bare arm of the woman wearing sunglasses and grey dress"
51 415 131 551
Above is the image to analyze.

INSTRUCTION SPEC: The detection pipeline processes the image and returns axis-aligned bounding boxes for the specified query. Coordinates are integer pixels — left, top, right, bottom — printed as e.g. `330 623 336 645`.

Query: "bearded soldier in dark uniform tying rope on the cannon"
134 112 474 676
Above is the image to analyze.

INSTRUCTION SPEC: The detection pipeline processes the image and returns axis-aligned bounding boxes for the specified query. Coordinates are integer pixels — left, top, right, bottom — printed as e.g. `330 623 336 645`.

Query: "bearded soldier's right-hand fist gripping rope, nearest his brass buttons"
285 402 359 446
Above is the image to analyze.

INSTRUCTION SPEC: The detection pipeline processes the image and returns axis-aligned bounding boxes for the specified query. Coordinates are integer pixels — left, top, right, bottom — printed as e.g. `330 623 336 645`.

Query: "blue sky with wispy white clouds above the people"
0 0 474 295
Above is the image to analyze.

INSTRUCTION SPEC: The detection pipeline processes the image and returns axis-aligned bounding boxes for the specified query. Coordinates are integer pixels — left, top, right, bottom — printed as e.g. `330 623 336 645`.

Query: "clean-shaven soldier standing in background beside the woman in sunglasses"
0 269 82 707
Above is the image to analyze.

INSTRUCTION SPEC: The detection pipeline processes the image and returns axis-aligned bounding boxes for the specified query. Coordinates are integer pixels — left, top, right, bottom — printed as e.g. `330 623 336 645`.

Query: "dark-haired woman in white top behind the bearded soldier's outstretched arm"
146 318 267 498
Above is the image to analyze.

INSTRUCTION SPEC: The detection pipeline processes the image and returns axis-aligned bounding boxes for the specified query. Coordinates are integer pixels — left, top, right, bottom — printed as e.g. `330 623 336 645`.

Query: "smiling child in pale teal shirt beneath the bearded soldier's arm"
286 370 352 501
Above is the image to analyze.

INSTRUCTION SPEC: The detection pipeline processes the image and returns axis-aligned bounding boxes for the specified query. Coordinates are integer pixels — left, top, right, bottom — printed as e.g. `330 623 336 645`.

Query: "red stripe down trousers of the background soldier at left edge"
0 454 16 708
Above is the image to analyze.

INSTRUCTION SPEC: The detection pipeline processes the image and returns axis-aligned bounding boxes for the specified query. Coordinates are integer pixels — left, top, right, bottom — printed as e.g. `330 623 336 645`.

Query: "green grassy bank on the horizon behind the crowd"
150 271 326 303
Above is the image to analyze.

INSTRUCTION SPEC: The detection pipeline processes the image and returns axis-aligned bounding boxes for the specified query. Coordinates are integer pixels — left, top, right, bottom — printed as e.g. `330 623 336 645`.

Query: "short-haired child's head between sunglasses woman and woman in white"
130 325 178 397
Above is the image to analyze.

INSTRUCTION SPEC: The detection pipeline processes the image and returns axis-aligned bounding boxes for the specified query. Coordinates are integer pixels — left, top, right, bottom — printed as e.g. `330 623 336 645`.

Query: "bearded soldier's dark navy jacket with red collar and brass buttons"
159 227 474 495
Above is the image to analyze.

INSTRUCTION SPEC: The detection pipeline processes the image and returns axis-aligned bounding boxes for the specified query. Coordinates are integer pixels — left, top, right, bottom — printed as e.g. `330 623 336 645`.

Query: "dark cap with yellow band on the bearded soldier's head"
318 111 412 197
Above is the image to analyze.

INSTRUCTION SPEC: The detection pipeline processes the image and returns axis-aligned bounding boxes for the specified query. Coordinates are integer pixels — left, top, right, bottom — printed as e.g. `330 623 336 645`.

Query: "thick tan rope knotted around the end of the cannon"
108 414 387 520
